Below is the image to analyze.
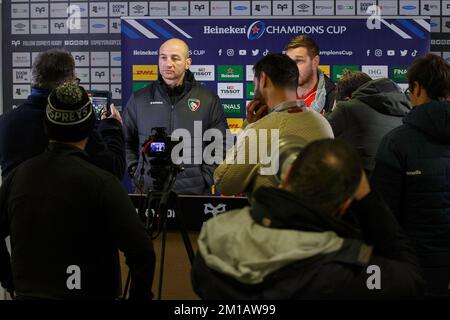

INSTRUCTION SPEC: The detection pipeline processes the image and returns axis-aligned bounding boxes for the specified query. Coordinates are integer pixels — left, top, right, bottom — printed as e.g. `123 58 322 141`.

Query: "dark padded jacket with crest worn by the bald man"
124 70 228 194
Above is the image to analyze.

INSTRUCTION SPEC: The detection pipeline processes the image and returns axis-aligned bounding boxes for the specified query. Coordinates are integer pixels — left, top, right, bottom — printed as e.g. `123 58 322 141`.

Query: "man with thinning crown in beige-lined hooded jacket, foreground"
192 139 423 300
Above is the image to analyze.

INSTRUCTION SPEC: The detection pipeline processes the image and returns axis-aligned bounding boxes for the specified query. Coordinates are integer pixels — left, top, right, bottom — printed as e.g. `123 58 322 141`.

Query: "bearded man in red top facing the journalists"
286 35 335 114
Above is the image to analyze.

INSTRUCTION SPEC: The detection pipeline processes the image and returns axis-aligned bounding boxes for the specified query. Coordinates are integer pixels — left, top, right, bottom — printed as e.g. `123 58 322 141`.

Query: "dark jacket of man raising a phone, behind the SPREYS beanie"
0 92 125 179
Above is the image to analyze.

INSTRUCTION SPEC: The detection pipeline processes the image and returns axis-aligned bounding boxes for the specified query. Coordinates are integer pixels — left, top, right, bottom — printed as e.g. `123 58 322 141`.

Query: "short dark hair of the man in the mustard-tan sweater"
253 53 298 90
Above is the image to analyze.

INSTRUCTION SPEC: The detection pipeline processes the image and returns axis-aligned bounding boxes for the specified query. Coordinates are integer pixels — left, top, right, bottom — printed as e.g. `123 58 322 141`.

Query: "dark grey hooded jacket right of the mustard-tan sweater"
328 78 410 172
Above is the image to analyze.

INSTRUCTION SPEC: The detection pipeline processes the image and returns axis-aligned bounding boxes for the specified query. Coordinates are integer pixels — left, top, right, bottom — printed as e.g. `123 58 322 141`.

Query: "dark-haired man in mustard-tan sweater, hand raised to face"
214 53 333 198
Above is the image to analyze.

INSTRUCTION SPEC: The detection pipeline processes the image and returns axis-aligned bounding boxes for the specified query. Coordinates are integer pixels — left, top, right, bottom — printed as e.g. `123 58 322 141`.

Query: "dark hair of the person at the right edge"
406 53 450 100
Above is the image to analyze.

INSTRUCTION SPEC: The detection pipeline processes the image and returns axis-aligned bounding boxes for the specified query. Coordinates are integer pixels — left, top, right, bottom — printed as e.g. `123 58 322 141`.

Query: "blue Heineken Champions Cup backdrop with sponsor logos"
122 17 430 129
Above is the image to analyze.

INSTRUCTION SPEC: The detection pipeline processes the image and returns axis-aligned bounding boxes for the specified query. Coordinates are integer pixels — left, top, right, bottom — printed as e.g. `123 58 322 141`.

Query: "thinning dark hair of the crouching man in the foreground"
287 139 363 214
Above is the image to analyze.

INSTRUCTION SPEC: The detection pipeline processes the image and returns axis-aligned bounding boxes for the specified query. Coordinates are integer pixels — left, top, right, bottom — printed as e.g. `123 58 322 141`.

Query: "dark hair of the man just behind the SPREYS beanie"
33 49 75 91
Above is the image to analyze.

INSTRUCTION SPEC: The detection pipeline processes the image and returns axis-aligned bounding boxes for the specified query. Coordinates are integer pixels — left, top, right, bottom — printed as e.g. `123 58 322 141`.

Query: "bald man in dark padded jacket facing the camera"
124 39 228 195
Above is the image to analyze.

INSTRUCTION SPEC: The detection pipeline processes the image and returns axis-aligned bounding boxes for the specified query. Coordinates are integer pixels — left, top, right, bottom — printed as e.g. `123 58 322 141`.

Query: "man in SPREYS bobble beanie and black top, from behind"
0 82 155 299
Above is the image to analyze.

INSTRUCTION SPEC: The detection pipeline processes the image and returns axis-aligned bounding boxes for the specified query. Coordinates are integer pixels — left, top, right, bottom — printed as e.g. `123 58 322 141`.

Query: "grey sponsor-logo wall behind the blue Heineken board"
1 0 450 111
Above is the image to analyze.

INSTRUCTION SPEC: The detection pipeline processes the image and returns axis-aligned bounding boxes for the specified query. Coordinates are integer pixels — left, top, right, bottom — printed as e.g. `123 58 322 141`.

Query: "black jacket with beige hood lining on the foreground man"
192 187 423 300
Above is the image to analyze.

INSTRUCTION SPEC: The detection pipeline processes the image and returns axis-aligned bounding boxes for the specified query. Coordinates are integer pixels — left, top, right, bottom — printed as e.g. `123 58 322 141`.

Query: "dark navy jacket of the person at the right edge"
372 101 450 296
